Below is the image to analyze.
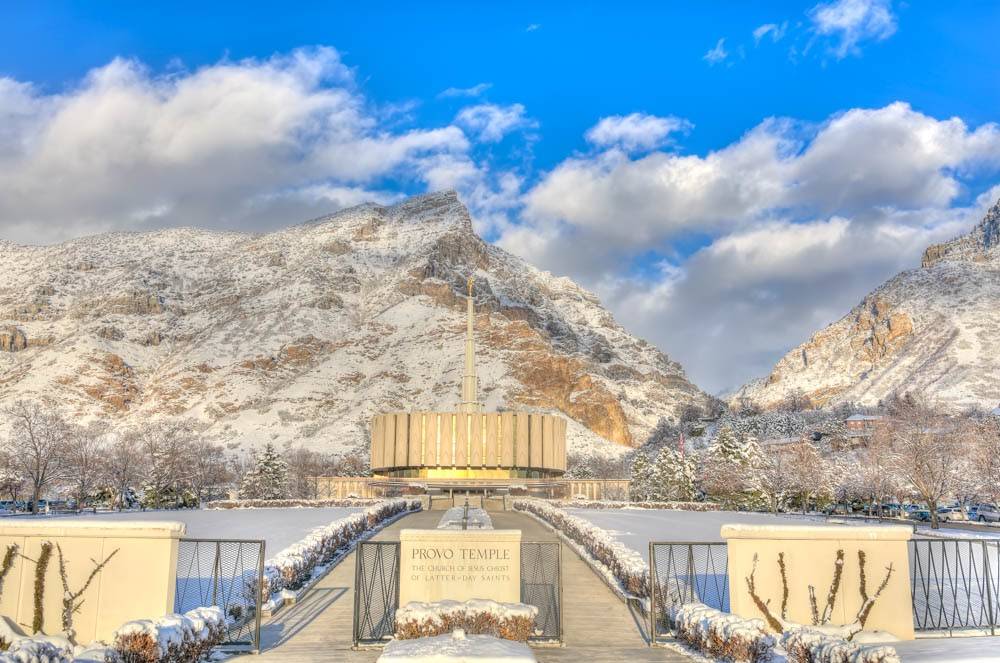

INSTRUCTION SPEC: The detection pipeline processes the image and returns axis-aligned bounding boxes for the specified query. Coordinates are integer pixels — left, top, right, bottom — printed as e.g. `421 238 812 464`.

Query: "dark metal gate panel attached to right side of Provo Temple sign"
521 541 563 642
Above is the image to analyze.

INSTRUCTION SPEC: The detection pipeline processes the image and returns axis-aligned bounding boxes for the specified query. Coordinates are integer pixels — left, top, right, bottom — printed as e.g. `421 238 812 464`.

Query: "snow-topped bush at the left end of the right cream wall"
674 603 775 663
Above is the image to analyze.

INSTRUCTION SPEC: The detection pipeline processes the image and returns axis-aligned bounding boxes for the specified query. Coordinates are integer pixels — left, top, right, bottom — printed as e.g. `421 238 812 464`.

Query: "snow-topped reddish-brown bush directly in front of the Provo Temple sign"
396 599 538 642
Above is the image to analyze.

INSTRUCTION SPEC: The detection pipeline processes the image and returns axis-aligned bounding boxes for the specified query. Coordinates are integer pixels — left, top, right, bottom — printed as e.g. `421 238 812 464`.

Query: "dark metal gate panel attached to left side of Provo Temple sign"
354 541 399 647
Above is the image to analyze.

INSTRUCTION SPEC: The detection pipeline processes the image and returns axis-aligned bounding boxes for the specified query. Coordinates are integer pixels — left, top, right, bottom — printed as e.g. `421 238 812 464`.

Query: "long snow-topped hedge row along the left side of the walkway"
256 499 421 597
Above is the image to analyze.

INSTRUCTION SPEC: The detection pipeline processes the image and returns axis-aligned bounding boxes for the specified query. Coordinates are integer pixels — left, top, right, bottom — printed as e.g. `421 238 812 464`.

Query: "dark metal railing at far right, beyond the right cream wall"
909 539 1000 635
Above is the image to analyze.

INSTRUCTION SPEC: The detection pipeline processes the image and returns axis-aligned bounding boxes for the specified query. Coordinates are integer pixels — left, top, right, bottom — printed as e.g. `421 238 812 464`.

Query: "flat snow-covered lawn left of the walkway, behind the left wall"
42 507 362 557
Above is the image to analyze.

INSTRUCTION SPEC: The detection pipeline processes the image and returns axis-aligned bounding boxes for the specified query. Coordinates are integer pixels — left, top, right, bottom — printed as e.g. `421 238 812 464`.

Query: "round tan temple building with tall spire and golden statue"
316 278 627 497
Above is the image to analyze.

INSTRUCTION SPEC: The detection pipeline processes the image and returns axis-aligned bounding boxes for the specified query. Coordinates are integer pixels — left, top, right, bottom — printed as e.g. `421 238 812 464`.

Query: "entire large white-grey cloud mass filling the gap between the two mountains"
499 103 1000 391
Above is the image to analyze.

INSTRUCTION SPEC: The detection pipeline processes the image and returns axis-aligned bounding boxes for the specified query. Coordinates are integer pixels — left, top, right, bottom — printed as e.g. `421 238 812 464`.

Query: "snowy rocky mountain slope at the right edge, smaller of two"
734 202 1000 408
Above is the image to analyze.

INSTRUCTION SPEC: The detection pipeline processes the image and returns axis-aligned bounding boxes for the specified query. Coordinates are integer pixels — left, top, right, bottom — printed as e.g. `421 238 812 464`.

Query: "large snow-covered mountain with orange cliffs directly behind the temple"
0 192 708 451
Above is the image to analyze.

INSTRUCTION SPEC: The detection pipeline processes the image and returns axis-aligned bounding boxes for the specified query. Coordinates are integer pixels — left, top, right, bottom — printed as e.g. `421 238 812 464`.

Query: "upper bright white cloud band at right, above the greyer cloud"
525 103 1000 254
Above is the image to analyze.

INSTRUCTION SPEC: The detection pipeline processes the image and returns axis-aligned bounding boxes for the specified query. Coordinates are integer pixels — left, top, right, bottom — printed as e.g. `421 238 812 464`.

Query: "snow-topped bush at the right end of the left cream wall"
112 606 226 663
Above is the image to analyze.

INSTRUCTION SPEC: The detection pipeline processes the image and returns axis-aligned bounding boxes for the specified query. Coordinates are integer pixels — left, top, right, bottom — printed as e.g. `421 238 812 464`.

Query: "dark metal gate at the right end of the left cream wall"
174 539 264 652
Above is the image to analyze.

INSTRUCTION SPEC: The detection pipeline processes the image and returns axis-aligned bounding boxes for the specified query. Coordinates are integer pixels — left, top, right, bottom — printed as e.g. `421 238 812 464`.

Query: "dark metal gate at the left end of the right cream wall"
649 541 729 644
